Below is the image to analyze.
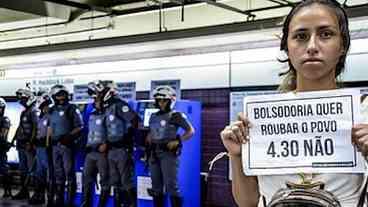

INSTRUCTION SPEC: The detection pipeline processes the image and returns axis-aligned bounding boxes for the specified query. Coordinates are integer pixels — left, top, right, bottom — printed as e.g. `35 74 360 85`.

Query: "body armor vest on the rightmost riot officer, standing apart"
149 111 178 144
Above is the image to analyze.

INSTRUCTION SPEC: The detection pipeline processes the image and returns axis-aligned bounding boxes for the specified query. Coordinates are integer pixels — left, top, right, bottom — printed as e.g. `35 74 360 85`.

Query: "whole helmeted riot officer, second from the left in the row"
12 88 38 200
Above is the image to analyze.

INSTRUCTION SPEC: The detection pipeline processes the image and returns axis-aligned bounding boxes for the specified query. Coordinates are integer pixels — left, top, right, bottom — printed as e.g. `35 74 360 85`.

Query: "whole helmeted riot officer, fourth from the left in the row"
48 85 83 206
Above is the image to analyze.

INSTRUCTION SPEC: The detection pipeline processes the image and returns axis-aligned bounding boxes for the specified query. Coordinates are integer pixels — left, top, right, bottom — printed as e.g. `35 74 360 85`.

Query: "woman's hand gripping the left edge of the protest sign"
221 113 251 156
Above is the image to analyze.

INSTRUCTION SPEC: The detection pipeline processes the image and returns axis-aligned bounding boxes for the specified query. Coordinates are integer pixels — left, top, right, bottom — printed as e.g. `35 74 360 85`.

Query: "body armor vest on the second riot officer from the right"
105 103 130 143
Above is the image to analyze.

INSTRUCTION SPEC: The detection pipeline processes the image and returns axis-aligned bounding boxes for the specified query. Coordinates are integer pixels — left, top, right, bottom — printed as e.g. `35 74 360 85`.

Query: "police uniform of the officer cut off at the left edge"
0 116 11 197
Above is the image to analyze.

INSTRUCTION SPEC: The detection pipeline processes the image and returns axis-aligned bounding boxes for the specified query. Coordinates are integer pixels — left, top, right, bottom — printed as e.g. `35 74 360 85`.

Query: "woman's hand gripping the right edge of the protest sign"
351 124 368 156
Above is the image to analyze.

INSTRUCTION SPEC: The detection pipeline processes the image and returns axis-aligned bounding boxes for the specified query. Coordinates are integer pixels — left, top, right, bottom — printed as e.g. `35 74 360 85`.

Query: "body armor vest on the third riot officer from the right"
87 113 107 149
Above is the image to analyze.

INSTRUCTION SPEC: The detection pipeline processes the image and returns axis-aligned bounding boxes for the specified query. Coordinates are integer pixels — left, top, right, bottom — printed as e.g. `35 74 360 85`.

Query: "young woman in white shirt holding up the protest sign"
221 0 368 207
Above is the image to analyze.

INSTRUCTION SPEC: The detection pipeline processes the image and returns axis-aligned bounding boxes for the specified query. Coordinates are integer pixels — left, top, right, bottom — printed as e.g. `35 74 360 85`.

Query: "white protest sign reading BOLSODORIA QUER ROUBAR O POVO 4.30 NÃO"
242 89 365 175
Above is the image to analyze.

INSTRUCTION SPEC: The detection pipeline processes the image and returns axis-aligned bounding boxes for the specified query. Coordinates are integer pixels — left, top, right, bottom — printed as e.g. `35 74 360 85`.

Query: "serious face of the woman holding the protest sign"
287 4 344 87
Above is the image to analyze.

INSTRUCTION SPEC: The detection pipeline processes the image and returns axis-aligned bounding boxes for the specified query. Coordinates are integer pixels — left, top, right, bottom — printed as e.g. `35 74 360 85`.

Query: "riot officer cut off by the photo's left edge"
0 98 12 198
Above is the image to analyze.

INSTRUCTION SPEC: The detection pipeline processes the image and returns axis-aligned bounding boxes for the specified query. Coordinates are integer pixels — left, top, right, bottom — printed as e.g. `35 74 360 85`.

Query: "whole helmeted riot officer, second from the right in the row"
99 81 138 207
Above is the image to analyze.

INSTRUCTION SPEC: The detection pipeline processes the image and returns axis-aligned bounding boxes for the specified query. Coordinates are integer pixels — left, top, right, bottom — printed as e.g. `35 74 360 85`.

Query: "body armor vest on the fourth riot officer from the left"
50 105 72 142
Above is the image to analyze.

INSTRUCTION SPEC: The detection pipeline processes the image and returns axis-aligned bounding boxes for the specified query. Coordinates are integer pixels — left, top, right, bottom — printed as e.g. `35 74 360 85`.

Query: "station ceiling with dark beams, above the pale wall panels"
0 0 368 55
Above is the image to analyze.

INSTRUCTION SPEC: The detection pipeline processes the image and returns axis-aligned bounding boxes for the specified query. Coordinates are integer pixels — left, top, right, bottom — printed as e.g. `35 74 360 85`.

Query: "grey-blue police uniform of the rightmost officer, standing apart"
149 111 191 205
